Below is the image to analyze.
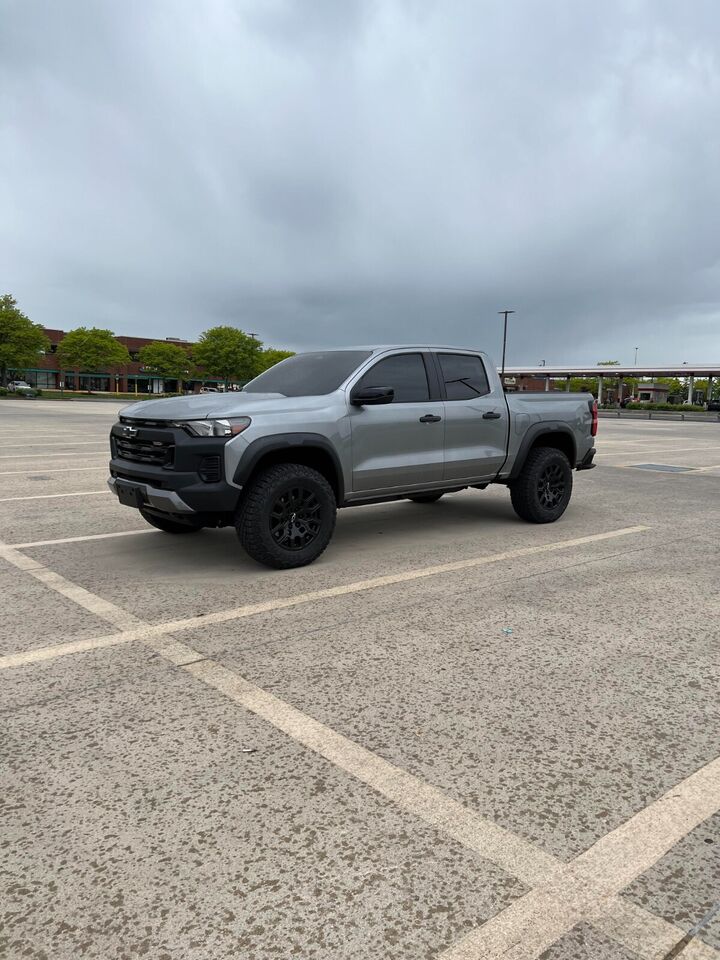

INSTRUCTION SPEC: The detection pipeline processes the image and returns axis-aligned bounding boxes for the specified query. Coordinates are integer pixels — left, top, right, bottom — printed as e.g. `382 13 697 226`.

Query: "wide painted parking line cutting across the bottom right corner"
440 758 720 960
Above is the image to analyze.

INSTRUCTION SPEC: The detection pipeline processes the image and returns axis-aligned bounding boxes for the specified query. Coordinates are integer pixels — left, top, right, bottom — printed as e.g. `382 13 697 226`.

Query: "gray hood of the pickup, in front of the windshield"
120 391 328 420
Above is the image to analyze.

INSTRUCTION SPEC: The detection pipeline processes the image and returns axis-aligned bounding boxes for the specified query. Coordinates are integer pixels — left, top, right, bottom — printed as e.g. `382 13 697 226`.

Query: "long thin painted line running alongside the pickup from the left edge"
0 526 650 670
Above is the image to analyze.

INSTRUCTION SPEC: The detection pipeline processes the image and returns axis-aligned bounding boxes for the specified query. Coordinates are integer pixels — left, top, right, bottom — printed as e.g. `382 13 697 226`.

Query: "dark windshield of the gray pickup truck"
243 350 370 397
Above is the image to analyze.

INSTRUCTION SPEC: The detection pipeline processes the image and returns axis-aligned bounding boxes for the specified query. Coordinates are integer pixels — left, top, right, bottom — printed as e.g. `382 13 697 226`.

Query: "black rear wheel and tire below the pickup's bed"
510 447 572 523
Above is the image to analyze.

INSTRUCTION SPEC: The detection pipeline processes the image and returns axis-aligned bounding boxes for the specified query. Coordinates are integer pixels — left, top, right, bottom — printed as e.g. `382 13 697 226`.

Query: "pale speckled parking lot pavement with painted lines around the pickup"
0 400 720 960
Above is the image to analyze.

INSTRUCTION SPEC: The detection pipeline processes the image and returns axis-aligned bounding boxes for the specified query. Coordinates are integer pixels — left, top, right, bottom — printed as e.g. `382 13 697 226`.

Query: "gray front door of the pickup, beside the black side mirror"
349 351 444 494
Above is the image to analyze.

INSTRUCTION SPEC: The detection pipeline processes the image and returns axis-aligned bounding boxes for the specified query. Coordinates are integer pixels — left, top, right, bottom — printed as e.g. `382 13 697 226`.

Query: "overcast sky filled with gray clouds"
0 0 720 363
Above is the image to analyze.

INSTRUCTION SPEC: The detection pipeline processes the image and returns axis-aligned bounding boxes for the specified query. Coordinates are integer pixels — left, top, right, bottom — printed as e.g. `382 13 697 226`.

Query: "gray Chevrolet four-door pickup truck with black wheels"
108 346 597 568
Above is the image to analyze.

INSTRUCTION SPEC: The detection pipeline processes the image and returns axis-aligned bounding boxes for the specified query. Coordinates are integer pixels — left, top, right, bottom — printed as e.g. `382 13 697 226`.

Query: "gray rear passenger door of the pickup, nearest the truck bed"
436 351 509 480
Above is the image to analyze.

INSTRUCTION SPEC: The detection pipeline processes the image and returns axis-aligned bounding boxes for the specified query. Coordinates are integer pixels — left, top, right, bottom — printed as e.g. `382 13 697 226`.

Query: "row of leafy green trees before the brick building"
0 293 293 387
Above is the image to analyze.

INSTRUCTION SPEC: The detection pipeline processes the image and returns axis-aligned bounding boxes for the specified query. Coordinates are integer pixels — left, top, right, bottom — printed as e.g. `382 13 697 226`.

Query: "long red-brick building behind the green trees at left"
13 328 222 393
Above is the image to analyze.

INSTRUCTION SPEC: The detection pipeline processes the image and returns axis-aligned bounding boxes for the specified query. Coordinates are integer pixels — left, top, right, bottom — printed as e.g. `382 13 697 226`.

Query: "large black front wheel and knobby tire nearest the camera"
235 463 337 570
